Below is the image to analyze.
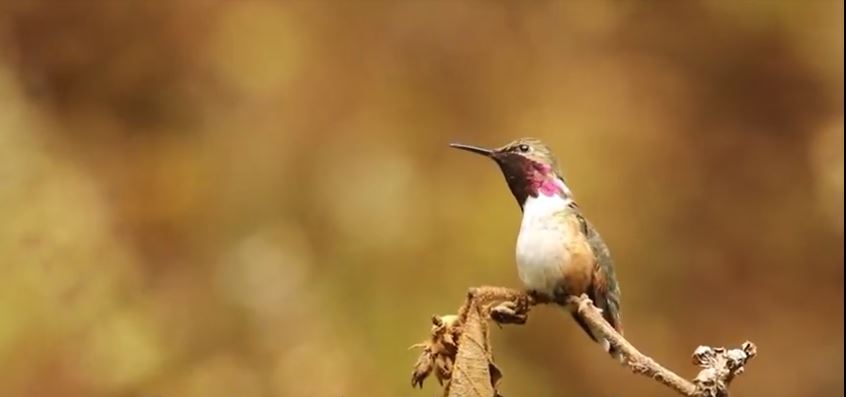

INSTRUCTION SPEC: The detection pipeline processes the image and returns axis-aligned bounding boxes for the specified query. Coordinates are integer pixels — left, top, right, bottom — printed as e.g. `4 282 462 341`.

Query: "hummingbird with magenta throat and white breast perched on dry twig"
450 138 623 359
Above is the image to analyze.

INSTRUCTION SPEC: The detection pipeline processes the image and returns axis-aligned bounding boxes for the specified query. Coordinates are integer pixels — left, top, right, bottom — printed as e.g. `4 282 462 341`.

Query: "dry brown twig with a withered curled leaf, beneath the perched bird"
412 287 756 397
